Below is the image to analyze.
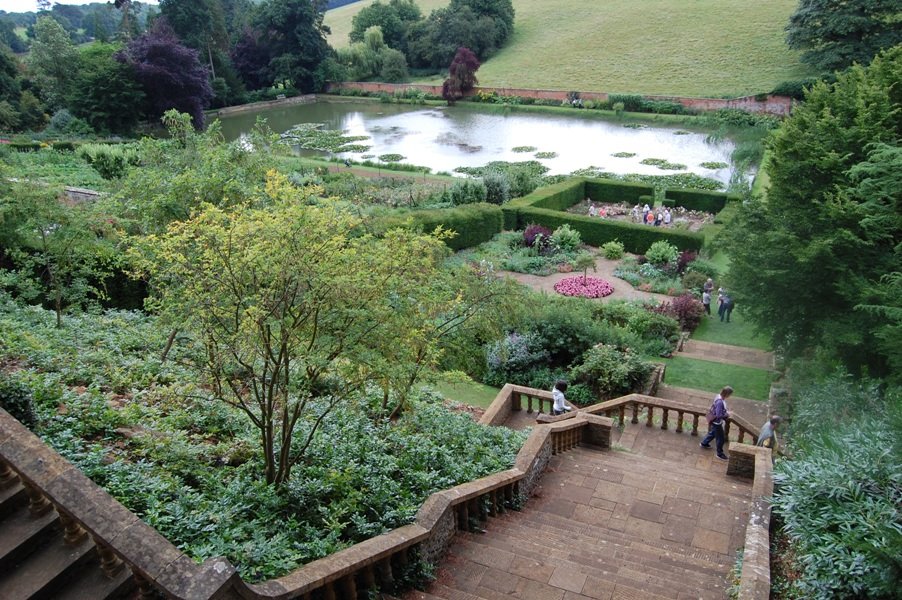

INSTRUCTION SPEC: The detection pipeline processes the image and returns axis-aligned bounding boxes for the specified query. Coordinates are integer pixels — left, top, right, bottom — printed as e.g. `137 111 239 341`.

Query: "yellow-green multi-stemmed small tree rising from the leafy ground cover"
134 174 474 485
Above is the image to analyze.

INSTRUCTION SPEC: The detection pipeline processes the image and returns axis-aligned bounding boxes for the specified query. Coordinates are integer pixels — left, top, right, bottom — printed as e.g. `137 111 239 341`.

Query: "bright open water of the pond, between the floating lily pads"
215 102 734 183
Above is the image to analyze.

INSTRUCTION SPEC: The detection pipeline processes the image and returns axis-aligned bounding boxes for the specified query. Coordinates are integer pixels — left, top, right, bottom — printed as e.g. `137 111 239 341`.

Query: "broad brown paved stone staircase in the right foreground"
405 425 751 600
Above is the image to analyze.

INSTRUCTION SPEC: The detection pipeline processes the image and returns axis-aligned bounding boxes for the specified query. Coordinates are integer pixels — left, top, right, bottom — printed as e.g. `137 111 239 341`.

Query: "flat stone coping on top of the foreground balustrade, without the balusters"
0 408 611 600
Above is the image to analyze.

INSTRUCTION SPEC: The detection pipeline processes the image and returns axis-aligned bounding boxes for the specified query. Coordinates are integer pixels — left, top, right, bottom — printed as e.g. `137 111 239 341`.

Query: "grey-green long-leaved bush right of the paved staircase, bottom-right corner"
773 374 902 599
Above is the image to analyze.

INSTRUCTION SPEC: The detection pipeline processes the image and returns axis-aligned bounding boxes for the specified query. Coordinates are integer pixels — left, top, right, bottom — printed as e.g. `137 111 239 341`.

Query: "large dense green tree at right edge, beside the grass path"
727 47 902 374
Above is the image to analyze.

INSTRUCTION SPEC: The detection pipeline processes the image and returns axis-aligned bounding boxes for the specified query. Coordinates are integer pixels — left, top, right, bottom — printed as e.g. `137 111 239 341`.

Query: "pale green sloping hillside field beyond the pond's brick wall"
325 0 809 97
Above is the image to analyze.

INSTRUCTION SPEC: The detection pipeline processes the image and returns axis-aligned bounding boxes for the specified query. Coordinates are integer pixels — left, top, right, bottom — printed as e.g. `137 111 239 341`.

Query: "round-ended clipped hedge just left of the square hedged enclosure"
376 203 504 251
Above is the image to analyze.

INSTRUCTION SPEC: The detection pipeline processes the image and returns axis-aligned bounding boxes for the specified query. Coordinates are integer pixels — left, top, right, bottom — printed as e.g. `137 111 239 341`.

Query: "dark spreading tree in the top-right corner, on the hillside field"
786 0 902 71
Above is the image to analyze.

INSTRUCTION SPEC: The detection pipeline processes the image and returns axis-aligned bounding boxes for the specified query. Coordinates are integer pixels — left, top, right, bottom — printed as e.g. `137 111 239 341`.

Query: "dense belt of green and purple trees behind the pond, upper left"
0 0 514 135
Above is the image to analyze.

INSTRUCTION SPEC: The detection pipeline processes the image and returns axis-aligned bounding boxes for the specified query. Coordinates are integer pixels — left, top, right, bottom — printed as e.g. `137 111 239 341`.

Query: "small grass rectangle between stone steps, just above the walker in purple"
665 356 774 402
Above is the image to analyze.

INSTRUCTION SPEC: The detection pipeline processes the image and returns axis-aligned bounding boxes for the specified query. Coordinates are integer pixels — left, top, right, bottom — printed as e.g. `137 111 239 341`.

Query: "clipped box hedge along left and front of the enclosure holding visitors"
501 177 705 254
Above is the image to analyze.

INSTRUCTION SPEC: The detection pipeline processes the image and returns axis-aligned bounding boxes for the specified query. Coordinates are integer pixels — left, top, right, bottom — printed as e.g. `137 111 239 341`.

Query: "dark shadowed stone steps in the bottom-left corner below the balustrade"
0 478 135 600
